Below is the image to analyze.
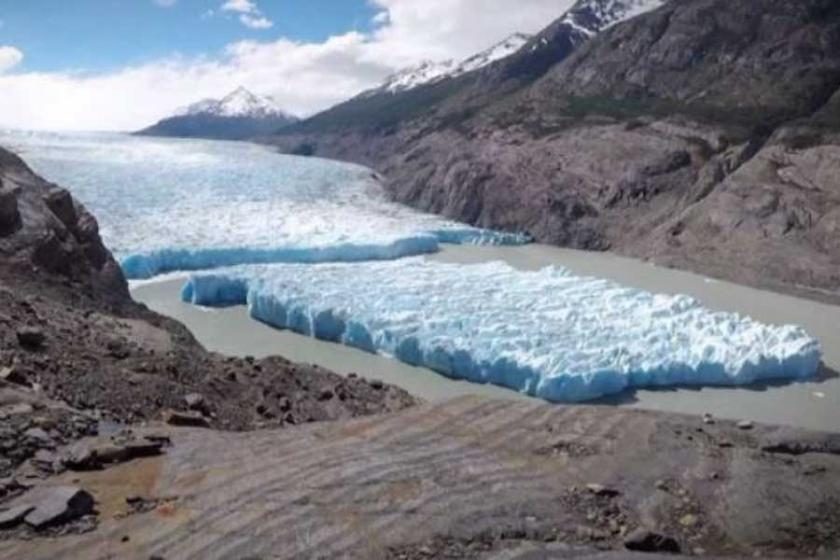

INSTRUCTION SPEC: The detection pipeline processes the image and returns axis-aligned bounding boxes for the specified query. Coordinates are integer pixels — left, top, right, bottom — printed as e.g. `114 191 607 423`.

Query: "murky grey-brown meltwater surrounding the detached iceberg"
132 244 840 432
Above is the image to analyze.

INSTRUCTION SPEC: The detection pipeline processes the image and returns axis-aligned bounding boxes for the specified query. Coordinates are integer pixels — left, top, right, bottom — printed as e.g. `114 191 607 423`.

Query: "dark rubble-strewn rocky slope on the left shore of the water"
0 149 413 476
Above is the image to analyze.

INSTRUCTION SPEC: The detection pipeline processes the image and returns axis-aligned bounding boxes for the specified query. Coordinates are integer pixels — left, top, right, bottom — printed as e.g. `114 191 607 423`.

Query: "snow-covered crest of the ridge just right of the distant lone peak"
362 33 530 97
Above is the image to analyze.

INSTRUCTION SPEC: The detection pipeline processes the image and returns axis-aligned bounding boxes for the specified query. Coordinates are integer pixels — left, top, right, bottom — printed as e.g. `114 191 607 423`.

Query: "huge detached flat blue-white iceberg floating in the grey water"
182 257 821 402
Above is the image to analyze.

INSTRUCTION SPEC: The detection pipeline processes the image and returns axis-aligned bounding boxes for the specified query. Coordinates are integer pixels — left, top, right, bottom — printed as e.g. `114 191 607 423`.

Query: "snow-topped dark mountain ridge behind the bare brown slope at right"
277 0 664 145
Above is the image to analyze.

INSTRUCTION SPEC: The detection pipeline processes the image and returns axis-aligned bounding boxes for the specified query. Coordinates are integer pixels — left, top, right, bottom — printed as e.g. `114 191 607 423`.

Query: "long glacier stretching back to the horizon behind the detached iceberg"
0 131 530 279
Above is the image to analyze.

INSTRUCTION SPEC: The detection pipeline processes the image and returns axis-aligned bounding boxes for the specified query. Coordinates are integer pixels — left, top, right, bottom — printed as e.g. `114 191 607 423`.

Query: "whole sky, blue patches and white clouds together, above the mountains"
0 0 574 130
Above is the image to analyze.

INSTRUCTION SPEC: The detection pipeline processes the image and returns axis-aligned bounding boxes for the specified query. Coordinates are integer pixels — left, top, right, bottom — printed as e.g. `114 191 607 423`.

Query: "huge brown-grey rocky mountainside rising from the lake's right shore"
275 0 840 300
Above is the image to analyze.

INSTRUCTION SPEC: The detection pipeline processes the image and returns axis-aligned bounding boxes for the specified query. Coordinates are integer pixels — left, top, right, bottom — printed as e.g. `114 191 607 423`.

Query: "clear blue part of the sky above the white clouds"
0 0 376 72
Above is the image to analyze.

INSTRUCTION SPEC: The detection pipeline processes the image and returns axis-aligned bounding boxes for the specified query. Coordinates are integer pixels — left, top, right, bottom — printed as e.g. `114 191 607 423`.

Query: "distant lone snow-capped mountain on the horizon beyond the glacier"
137 87 298 140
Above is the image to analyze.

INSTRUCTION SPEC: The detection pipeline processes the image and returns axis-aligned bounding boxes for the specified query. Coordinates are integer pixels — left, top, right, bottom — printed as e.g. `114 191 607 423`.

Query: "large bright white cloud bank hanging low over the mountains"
0 0 572 130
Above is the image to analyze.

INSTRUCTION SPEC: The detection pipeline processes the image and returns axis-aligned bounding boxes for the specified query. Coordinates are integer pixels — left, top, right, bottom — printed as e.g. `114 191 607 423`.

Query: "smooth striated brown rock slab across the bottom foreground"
0 398 840 560
